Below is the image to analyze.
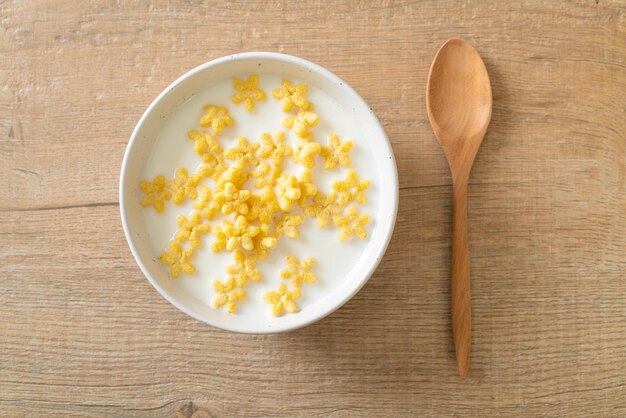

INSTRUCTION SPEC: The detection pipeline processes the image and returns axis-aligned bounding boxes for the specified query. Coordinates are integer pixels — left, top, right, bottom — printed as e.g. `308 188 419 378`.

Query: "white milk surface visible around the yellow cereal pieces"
138 72 381 316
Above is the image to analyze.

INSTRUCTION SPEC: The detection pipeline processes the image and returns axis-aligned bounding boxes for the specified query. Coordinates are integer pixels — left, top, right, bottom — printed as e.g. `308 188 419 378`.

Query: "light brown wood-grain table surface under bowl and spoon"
0 0 626 417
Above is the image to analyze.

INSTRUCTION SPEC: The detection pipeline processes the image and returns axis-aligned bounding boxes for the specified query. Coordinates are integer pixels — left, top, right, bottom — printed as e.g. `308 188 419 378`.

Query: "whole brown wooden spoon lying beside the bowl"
426 39 492 378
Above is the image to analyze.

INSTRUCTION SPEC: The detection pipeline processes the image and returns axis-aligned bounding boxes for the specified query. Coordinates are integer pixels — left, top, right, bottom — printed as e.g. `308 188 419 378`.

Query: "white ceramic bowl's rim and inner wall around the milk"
120 52 398 333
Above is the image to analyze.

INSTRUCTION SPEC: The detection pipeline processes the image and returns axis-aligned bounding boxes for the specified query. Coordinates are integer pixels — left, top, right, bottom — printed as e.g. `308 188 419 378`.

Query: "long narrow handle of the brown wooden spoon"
451 180 472 378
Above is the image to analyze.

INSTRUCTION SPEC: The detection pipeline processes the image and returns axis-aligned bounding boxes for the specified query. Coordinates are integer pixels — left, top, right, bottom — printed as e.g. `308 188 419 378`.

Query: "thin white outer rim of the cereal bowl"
119 51 400 334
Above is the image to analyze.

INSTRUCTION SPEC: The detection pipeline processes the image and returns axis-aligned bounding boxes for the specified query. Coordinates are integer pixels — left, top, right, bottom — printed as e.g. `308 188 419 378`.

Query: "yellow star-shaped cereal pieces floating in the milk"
140 75 370 316
